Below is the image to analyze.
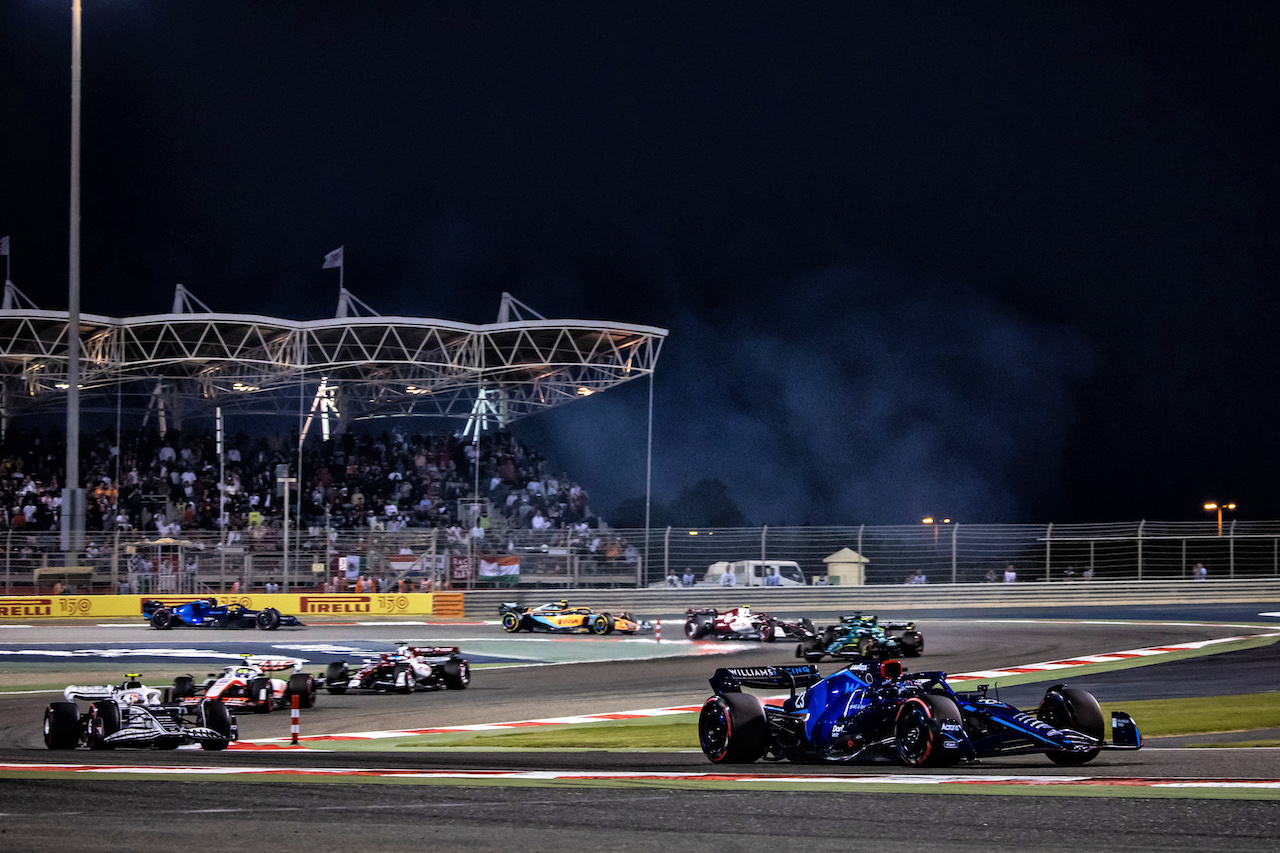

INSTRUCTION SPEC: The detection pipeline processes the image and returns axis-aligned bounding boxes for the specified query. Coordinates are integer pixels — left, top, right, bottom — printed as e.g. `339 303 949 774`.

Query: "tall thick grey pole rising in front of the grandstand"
61 0 84 550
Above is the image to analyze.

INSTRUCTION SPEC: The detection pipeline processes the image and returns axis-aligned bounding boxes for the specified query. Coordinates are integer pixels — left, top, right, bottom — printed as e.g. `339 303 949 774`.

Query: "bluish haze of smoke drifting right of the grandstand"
519 261 1089 524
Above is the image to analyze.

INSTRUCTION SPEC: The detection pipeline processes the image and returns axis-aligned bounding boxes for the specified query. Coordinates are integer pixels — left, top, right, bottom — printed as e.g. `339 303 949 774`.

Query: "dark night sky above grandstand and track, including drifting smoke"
0 0 1280 524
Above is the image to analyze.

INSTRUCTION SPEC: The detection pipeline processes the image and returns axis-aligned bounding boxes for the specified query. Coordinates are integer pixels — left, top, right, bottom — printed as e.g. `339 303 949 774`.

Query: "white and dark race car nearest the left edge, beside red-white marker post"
45 674 237 749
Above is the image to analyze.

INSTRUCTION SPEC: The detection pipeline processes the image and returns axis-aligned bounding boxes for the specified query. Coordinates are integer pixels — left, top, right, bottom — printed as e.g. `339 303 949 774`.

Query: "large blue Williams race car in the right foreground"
698 661 1142 767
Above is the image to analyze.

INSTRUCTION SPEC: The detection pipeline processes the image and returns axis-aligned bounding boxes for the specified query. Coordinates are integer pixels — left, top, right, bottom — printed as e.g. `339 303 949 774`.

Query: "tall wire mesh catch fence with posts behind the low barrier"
0 520 1280 592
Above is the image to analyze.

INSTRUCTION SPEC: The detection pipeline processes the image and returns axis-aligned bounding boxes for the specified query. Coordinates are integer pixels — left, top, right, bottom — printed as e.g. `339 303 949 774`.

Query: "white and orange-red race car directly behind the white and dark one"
172 654 316 713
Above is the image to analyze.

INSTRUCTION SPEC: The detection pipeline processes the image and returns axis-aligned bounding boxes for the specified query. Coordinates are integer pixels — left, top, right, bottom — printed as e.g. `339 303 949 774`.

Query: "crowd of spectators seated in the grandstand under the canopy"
0 428 599 540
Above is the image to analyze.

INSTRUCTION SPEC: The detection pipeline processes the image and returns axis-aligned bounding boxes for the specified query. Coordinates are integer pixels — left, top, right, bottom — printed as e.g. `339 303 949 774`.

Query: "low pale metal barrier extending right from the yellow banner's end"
455 579 1280 619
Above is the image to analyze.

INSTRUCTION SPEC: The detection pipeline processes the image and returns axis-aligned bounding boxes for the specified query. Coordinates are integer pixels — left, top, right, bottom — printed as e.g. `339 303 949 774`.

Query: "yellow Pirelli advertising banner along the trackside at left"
0 593 434 624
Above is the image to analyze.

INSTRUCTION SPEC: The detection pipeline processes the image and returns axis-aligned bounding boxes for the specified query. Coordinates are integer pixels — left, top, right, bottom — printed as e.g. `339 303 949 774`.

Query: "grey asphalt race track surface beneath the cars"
0 596 1280 853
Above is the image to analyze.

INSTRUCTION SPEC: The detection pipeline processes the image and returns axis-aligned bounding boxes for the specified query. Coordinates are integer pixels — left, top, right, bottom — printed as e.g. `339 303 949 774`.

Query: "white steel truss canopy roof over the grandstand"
0 283 667 424
